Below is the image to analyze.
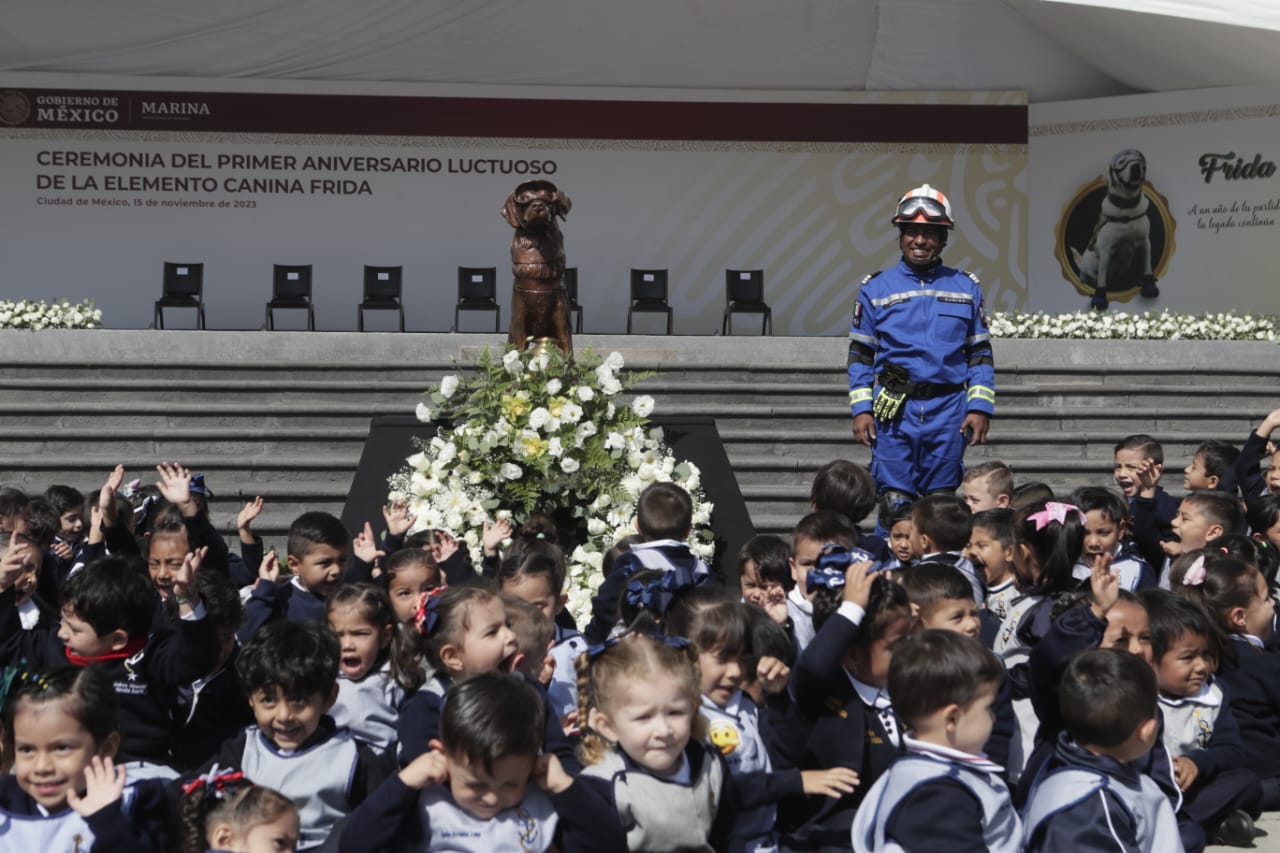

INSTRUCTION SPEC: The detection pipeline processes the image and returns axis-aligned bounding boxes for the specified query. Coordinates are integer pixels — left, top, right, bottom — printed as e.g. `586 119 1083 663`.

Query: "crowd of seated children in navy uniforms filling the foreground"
0 410 1280 853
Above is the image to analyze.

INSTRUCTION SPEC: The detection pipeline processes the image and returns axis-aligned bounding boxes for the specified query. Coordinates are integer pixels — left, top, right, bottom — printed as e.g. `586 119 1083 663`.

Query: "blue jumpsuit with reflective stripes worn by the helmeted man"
849 261 996 494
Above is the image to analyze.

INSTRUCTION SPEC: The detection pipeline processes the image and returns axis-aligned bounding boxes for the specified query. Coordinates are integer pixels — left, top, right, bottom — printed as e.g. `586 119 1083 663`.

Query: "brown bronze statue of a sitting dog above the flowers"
502 181 573 355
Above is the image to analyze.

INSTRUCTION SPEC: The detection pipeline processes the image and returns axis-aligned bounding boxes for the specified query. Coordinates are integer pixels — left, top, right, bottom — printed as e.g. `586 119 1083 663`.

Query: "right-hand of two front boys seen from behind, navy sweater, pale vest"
1023 648 1184 853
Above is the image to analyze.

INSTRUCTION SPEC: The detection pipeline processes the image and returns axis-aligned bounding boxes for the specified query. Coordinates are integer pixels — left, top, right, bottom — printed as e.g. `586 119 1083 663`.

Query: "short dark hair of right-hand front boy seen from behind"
1054 648 1158 749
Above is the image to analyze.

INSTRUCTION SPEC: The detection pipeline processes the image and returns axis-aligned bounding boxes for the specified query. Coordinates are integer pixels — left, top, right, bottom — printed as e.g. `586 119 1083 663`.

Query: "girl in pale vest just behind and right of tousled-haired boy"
325 584 420 753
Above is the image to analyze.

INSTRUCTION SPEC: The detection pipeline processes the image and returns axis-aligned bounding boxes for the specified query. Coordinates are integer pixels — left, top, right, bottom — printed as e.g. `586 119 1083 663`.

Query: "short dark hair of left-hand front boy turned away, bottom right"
888 625 1005 726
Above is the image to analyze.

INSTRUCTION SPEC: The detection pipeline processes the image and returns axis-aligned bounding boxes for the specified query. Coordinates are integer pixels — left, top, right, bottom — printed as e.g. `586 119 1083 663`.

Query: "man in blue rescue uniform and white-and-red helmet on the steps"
849 184 996 522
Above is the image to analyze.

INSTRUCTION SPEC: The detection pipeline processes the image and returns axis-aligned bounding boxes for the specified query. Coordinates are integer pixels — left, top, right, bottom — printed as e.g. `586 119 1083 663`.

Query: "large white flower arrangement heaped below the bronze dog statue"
389 348 714 624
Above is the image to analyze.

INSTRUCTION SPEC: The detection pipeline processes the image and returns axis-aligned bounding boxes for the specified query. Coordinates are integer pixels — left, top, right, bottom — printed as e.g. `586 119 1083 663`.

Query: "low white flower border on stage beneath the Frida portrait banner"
987 311 1280 341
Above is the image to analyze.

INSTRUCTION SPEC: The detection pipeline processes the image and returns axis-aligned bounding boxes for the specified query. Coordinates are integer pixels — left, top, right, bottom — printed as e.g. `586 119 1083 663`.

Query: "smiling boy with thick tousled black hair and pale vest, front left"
196 620 393 850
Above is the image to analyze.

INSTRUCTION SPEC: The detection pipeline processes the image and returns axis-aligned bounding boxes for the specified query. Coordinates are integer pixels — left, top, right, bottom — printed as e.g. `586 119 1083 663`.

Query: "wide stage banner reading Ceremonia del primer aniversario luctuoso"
0 74 1027 334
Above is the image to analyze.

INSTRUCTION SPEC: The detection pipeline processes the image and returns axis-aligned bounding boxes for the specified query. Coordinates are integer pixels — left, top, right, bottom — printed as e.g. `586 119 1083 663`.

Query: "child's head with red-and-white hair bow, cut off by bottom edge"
179 767 301 853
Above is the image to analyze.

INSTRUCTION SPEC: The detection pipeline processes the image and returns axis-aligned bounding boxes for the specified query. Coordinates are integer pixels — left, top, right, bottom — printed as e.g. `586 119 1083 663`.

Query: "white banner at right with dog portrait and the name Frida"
1027 88 1280 314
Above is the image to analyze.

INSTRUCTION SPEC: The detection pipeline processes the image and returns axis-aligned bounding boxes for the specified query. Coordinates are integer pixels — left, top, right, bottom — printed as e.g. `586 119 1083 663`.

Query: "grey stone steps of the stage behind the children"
0 329 1280 544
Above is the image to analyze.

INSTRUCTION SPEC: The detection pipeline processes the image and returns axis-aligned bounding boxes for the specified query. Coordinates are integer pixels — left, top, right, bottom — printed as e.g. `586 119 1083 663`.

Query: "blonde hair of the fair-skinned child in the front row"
575 634 707 765
